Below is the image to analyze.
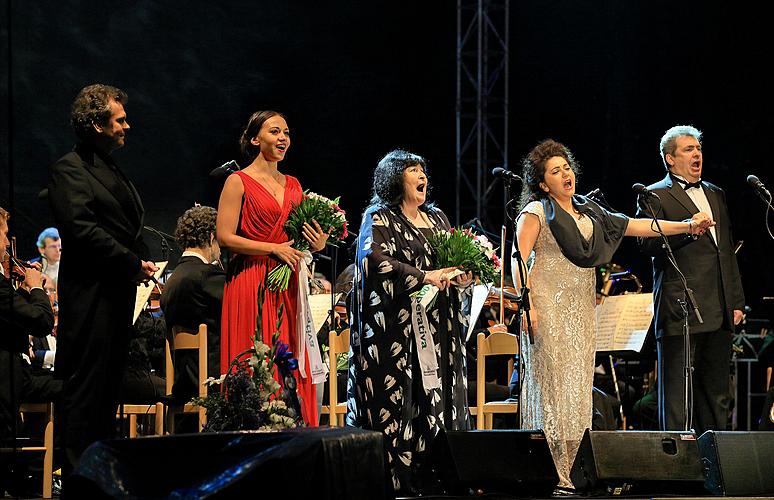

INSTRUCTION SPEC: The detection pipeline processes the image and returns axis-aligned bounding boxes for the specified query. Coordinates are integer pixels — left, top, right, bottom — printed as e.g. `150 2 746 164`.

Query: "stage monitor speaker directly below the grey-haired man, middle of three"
570 429 706 495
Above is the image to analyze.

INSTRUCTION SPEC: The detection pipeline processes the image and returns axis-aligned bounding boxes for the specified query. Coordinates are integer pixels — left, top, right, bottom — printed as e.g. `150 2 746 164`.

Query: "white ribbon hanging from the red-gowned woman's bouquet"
296 250 328 384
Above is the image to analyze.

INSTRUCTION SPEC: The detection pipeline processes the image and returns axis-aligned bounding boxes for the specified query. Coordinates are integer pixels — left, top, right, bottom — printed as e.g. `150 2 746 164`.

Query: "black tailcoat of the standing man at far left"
48 143 147 377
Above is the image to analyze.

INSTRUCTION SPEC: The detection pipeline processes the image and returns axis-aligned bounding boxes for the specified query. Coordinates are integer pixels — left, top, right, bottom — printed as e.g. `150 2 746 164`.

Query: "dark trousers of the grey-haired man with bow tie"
657 330 731 435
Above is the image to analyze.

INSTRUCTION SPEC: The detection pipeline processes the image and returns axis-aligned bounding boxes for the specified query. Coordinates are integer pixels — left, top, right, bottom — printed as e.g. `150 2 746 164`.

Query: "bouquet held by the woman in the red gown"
266 190 347 291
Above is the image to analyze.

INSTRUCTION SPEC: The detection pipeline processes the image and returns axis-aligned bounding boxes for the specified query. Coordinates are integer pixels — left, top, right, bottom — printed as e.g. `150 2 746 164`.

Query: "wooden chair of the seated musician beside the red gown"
166 323 207 434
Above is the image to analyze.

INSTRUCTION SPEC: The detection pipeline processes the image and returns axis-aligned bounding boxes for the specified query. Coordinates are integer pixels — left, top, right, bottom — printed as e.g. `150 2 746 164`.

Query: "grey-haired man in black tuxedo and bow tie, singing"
638 125 744 434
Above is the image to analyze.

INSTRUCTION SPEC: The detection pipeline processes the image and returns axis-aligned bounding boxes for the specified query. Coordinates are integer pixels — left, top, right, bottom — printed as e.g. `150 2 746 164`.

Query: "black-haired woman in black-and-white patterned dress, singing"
347 150 472 492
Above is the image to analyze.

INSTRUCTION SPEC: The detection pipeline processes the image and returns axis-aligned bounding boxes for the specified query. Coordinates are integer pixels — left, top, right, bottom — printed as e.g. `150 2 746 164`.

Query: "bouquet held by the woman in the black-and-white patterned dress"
428 228 501 283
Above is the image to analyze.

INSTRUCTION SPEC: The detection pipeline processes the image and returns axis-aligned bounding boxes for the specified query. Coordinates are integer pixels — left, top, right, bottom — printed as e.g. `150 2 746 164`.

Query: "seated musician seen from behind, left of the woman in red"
161 206 226 402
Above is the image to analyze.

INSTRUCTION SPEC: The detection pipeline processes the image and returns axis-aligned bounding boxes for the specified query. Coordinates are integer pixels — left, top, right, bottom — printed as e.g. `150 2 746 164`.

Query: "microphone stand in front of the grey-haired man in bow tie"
639 195 704 431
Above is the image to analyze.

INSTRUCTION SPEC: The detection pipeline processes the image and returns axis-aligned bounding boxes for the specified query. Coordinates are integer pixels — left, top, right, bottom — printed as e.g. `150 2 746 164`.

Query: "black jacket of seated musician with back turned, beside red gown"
160 256 226 398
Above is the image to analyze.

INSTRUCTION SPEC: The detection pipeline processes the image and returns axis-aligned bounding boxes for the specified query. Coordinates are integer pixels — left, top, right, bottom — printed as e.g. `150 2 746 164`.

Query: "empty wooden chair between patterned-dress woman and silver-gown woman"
476 332 519 430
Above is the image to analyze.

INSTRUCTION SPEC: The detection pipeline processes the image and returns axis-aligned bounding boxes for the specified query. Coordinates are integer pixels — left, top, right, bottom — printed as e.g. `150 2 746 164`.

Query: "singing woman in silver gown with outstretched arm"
511 139 714 489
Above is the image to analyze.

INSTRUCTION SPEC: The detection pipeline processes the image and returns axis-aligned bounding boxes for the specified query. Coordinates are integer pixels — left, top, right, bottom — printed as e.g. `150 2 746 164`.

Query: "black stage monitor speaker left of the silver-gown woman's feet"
424 430 559 497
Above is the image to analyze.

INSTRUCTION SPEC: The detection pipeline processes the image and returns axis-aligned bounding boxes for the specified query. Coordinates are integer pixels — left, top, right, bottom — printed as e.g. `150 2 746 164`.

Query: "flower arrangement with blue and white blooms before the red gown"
192 290 304 432
